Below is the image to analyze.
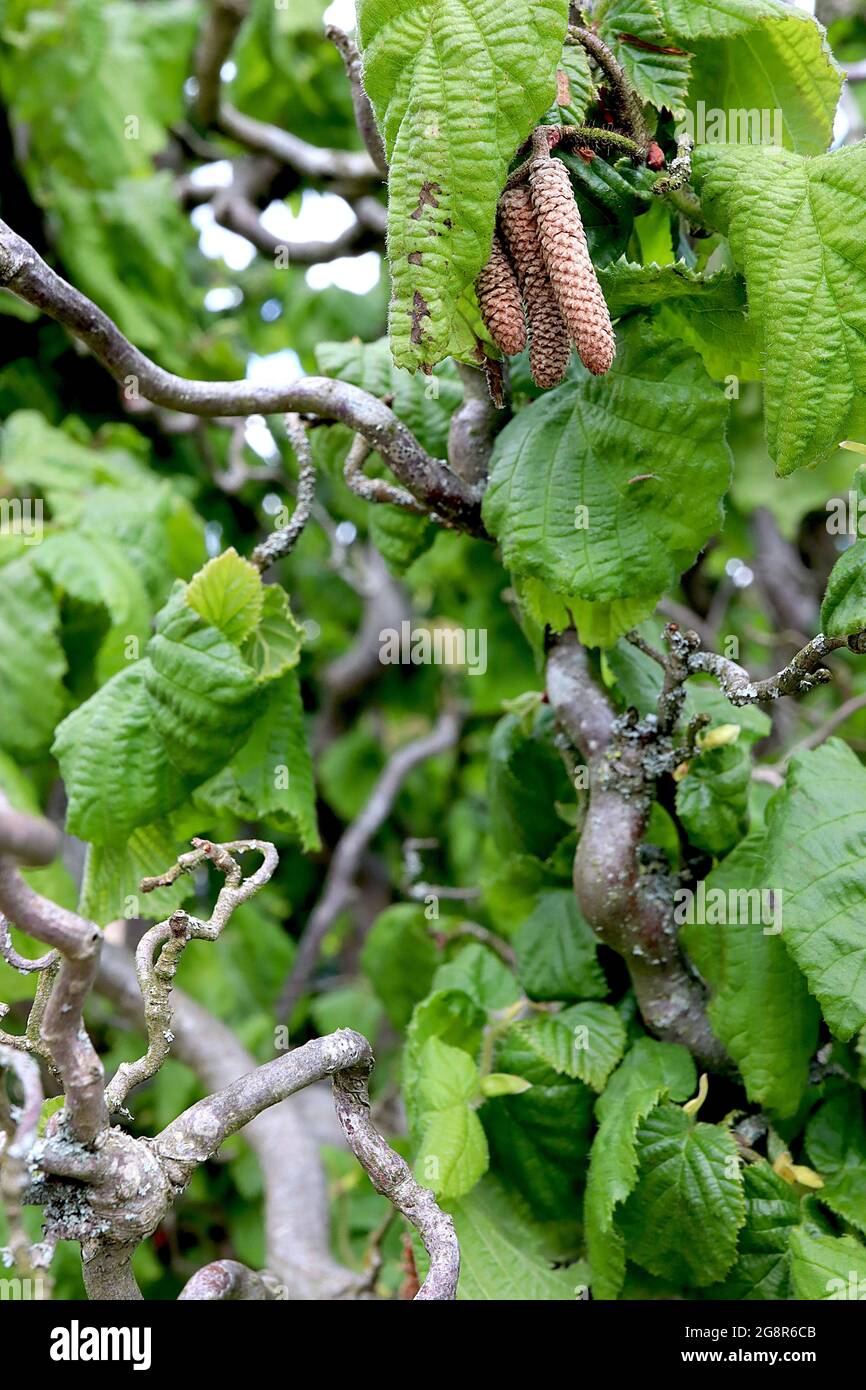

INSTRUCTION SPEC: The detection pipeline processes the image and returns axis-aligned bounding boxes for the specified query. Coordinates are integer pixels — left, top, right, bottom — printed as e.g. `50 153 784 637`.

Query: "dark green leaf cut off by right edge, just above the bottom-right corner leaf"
806 1087 866 1234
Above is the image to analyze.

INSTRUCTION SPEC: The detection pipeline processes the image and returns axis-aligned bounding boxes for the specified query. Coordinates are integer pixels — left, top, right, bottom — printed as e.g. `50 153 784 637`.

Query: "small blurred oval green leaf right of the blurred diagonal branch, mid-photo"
361 902 439 1029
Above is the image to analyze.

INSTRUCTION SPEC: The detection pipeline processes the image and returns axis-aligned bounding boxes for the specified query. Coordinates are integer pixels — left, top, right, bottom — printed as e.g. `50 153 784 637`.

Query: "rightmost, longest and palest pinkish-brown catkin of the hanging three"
530 158 616 377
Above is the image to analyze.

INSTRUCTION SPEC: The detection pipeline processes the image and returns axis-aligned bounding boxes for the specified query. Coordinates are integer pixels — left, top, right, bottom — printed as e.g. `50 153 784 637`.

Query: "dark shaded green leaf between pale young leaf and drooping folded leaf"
481 1027 592 1220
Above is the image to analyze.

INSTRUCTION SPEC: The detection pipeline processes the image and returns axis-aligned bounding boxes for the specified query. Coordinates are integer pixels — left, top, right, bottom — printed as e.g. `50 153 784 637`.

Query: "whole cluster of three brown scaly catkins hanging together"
475 154 616 386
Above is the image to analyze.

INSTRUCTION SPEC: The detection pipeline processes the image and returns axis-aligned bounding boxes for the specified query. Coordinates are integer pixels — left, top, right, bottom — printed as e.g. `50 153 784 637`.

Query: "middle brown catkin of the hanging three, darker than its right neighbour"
499 185 571 388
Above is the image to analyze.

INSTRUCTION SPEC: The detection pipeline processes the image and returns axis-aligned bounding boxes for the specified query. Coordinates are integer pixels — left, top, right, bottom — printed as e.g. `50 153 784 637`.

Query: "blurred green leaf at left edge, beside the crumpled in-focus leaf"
0 559 67 762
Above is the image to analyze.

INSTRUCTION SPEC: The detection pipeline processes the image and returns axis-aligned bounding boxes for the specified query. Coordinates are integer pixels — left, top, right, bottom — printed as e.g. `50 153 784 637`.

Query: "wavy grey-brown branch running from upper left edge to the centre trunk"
0 222 485 535
